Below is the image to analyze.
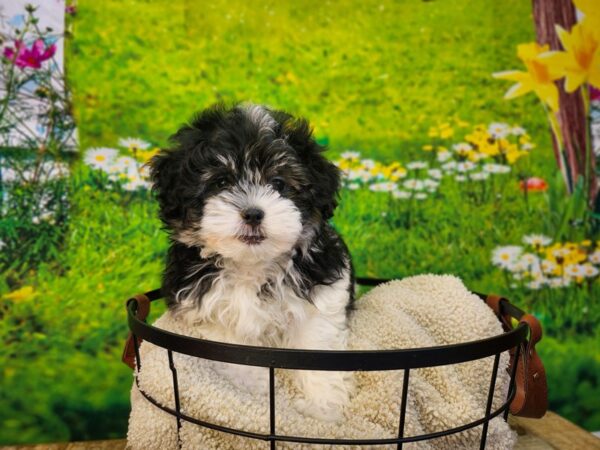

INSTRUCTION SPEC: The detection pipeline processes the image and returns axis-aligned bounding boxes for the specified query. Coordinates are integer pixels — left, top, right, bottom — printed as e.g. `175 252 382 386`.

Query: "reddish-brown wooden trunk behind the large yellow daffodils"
532 0 598 206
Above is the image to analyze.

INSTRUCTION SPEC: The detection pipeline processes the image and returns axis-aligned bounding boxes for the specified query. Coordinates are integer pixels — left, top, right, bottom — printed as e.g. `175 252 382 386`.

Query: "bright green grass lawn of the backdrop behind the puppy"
0 0 600 443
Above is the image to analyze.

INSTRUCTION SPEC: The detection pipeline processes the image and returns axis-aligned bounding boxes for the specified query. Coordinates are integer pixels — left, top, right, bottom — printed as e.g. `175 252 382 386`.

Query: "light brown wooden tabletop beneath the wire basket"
0 412 600 450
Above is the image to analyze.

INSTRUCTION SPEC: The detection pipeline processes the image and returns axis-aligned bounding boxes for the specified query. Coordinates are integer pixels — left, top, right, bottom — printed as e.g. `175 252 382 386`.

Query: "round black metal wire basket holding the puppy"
127 278 529 449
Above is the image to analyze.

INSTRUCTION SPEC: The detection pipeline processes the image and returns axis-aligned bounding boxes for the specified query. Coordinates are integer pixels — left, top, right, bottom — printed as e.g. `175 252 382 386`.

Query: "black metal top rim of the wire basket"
127 278 529 371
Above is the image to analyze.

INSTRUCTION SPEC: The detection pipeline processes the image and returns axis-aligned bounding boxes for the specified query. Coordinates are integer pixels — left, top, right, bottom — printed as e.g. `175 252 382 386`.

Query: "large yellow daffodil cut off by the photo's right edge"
541 21 600 92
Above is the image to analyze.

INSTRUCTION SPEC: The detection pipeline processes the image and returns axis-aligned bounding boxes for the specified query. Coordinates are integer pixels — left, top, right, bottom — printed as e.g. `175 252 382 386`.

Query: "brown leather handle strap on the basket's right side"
486 295 548 418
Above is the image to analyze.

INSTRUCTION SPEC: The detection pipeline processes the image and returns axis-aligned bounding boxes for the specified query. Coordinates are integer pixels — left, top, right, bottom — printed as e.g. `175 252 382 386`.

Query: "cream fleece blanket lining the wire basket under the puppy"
127 275 516 450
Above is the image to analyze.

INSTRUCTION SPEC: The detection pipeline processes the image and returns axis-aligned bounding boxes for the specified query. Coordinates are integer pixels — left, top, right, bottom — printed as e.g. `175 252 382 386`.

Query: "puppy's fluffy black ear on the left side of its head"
149 150 184 227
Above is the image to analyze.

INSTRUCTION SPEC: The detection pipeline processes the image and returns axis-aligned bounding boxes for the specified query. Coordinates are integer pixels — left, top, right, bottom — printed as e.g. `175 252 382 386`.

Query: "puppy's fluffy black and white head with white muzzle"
151 105 339 263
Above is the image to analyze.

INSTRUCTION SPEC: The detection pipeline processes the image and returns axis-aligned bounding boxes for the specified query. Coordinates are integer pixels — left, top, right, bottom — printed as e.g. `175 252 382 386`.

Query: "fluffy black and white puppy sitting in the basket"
151 105 354 420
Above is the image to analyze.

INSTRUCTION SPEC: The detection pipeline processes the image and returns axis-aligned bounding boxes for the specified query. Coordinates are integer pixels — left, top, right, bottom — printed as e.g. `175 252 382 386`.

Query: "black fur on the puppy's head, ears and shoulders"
150 105 354 310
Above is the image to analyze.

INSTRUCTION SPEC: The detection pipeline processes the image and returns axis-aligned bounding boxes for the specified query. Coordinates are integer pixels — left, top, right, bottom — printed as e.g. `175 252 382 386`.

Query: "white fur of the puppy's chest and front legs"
176 260 352 420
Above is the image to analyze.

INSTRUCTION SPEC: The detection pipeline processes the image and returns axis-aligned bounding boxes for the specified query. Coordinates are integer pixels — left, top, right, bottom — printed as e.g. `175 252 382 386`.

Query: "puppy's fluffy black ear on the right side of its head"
283 119 340 220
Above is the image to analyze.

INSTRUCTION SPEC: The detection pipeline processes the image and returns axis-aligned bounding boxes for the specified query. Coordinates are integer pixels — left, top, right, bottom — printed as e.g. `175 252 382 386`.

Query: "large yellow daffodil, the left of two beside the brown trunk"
493 42 561 111
